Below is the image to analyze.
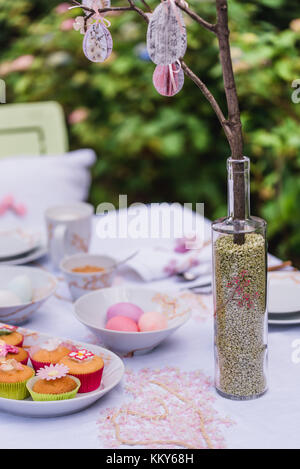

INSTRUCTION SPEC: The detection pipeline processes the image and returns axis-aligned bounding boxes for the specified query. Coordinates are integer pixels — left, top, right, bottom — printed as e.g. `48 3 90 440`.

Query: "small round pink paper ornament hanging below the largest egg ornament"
153 62 184 96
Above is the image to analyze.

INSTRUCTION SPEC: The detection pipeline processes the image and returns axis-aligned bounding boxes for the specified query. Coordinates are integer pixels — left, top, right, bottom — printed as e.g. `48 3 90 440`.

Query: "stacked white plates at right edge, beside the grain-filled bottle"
268 271 300 325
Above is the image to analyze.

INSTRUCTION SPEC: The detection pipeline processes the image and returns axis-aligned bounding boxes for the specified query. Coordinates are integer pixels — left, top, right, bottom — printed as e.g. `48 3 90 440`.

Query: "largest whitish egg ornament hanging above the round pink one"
147 0 187 65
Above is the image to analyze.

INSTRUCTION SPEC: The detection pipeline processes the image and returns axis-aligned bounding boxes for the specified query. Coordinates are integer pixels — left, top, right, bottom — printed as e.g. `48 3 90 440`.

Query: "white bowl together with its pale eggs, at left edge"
0 265 57 325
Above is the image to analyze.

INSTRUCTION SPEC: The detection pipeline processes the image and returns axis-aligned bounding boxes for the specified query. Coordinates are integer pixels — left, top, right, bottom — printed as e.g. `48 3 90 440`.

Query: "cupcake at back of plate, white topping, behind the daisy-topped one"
29 339 73 371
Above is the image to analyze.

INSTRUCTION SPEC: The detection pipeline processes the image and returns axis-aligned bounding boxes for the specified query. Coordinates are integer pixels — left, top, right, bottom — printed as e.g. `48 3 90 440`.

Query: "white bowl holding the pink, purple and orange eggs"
74 287 190 355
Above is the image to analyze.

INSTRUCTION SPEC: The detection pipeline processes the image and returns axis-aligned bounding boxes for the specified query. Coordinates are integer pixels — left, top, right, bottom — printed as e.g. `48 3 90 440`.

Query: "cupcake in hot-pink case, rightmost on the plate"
60 349 104 393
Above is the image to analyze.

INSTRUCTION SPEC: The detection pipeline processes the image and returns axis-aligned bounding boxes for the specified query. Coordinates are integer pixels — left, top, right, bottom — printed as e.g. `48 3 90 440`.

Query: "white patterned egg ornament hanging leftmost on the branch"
83 19 113 62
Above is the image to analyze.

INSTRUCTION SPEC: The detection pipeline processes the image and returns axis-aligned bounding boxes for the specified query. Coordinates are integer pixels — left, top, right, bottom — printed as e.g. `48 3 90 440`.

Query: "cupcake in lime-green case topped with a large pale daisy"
27 364 80 401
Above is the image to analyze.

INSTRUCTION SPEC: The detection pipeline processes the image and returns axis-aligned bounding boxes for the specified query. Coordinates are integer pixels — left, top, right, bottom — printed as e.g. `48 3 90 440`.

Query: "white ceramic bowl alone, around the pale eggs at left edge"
0 265 57 325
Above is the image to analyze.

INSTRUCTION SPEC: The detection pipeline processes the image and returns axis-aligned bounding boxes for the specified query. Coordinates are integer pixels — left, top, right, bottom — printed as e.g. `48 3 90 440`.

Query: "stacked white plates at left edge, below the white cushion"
0 228 47 265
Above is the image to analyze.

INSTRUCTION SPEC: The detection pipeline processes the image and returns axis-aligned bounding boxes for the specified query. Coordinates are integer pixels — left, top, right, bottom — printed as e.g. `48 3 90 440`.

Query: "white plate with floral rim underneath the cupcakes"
0 323 124 417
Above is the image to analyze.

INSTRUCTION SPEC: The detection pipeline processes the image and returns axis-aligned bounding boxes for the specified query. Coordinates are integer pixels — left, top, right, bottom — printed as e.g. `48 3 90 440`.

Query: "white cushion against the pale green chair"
0 149 96 228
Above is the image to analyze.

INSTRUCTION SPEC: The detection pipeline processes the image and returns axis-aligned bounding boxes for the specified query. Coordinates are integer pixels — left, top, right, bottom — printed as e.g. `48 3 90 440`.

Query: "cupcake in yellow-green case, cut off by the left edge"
0 359 34 399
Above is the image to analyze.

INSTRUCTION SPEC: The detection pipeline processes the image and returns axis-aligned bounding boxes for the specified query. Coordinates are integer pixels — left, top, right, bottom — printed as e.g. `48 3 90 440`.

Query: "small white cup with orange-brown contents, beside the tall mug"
59 254 116 300
